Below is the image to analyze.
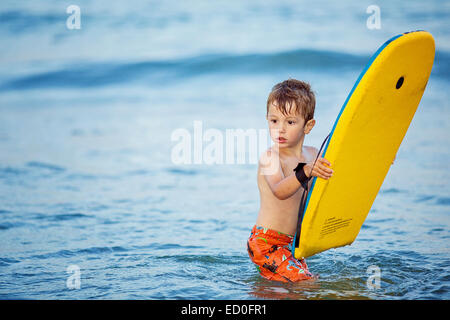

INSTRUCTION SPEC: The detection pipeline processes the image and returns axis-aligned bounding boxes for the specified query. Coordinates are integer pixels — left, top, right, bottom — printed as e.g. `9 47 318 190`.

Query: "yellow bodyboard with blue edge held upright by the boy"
293 31 435 259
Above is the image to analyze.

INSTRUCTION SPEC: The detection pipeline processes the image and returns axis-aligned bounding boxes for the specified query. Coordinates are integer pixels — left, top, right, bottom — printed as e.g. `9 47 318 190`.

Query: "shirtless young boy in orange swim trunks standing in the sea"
247 79 333 282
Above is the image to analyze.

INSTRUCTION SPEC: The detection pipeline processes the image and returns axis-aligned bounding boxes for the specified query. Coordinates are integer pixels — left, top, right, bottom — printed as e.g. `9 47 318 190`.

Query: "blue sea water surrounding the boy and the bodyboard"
0 0 450 299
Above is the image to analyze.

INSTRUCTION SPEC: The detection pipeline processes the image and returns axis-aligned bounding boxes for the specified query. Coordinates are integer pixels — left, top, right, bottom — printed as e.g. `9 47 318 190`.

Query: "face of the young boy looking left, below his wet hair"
267 104 315 148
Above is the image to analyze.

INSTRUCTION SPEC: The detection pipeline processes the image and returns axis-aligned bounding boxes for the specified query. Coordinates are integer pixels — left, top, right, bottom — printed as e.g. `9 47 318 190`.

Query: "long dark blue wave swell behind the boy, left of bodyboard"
0 50 369 91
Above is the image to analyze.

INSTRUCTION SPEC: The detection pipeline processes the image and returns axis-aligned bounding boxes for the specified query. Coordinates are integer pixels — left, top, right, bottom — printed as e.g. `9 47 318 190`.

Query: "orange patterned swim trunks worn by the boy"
247 226 313 282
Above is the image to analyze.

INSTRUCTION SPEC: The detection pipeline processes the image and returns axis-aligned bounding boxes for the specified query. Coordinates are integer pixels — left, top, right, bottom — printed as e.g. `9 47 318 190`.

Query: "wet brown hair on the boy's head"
266 79 316 123
